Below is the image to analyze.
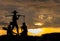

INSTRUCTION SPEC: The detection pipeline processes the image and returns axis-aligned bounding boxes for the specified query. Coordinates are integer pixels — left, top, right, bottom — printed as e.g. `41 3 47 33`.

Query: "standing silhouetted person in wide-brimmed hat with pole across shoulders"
12 10 20 34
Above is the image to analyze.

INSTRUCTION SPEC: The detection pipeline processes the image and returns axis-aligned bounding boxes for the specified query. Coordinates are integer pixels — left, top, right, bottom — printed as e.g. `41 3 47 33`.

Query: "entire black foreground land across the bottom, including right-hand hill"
0 33 60 41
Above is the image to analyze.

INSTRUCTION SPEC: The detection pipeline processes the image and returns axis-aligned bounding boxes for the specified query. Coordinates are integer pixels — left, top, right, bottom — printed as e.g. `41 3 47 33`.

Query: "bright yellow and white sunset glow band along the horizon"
0 27 60 36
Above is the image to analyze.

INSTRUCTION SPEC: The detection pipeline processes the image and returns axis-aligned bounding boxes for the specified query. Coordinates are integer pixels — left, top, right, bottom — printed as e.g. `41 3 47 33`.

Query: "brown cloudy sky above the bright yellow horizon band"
0 0 60 36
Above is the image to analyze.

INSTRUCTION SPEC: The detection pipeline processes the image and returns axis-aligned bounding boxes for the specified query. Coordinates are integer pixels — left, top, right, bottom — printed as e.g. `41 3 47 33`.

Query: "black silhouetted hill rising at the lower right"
37 33 60 41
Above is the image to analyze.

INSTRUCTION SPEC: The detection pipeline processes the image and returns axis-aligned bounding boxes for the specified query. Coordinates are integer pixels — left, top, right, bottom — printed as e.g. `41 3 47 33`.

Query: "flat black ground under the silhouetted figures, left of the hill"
0 35 39 41
